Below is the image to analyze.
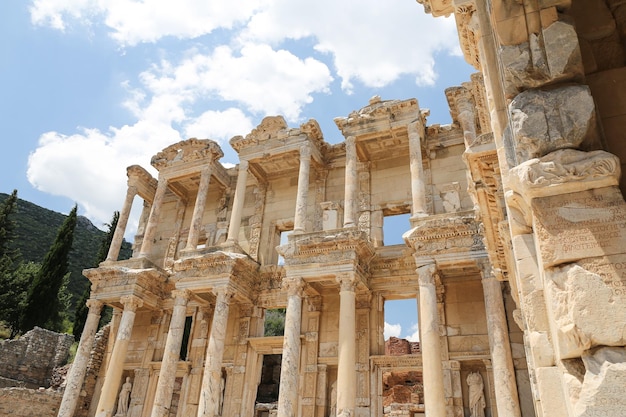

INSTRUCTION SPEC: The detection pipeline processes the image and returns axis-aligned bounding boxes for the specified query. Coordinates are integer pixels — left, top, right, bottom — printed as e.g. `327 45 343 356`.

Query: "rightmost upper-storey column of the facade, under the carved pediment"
407 118 428 217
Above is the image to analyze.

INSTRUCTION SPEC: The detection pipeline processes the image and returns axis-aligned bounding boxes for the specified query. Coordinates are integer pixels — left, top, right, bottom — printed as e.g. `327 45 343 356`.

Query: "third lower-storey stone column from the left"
151 290 191 417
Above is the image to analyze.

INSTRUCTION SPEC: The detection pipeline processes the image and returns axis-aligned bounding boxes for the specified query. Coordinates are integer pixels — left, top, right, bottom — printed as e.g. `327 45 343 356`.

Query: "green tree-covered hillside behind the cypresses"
0 190 131 315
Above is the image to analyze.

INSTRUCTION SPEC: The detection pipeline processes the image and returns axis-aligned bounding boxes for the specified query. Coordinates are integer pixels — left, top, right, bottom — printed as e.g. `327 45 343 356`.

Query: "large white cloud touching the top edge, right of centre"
241 0 458 91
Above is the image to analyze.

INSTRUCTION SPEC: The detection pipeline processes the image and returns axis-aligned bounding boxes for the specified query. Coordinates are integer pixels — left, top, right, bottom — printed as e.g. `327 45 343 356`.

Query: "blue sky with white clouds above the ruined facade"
0 0 473 336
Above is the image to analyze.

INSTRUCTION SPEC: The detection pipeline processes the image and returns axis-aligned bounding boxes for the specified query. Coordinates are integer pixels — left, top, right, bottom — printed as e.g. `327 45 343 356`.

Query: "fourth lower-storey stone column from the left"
198 287 233 417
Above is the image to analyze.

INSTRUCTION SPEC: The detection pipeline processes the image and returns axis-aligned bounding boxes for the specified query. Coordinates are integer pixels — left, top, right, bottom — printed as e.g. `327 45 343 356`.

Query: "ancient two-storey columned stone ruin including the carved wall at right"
58 0 626 417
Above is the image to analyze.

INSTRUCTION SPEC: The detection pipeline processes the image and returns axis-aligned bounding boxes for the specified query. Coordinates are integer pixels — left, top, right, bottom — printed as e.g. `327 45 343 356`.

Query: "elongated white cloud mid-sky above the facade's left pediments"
136 44 332 121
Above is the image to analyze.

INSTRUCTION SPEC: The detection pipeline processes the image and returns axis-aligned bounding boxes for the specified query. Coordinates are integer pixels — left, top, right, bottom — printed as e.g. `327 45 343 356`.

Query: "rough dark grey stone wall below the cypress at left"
0 327 74 388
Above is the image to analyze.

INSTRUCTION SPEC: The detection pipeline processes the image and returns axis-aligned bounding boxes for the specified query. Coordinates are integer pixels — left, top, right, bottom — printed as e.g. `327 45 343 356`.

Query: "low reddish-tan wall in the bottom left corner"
0 388 63 417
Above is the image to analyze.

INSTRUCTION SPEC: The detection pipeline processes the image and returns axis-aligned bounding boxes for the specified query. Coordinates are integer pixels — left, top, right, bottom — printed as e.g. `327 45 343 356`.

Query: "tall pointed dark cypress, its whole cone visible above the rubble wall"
22 206 77 331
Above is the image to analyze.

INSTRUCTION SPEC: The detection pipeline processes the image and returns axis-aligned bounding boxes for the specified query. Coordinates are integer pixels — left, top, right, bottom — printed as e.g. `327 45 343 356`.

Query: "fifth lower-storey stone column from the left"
278 278 304 417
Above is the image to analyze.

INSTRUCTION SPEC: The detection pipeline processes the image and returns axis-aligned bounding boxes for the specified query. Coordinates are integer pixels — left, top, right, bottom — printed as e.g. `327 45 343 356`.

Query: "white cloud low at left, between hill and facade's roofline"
27 122 181 228
